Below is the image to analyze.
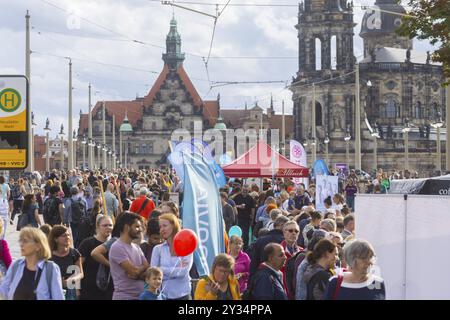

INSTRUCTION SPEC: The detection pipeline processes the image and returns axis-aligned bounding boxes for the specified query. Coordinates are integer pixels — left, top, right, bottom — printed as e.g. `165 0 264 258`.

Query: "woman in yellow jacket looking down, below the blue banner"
195 253 241 300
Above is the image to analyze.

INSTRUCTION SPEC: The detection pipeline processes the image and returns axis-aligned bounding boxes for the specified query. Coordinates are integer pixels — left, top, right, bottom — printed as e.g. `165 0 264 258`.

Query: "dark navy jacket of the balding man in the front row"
252 264 288 300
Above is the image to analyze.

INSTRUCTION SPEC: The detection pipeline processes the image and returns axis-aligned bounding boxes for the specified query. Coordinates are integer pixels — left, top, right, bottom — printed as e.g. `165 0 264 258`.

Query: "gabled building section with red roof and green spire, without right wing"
77 19 219 169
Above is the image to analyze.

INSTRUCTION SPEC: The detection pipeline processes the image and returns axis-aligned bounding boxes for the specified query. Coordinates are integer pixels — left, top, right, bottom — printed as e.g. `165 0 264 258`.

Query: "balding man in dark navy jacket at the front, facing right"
251 243 288 300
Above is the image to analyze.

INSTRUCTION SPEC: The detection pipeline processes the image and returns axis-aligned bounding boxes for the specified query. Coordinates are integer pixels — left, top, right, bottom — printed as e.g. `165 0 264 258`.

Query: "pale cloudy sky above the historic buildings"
0 0 432 133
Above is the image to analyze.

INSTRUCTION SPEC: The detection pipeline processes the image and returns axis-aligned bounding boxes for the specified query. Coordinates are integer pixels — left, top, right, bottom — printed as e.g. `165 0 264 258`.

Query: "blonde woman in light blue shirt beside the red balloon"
150 213 193 300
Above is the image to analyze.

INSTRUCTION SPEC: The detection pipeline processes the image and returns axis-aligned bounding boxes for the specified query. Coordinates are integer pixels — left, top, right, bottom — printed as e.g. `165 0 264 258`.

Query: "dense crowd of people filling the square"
0 169 386 300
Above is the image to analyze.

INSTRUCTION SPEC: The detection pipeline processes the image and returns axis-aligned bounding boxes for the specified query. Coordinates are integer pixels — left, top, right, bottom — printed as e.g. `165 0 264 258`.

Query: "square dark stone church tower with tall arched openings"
290 0 356 165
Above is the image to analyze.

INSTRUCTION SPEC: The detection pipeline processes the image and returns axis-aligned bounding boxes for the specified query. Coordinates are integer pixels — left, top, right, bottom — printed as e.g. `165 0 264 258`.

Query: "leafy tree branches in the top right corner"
398 0 450 79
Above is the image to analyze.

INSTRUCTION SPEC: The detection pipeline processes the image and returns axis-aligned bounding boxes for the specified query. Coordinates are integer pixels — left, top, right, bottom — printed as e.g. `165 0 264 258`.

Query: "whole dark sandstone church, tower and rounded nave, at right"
291 0 446 173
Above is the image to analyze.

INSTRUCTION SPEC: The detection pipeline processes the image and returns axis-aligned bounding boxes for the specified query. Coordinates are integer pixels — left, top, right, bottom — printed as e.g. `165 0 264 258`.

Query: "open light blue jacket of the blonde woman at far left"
0 258 64 300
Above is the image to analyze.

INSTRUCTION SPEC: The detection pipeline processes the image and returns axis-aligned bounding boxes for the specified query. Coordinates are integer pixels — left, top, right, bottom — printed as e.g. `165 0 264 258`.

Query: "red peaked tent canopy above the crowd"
222 141 309 178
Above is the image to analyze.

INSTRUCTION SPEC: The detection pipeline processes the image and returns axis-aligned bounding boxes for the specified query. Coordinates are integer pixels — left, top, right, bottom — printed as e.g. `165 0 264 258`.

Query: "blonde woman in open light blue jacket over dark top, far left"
0 227 64 300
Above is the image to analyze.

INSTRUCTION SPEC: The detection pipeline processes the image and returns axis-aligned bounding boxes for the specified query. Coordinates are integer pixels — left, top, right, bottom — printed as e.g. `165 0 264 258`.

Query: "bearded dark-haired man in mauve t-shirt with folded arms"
109 212 150 300
